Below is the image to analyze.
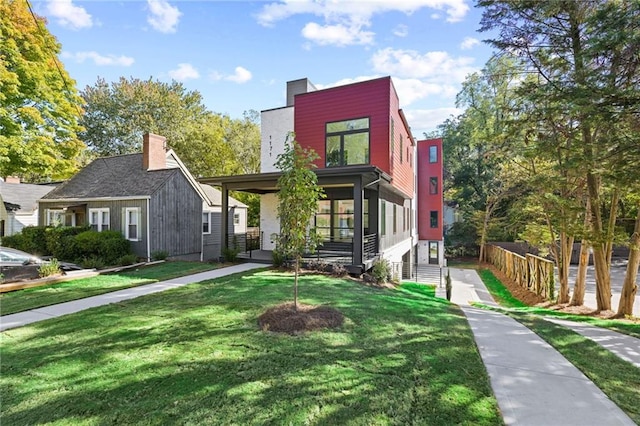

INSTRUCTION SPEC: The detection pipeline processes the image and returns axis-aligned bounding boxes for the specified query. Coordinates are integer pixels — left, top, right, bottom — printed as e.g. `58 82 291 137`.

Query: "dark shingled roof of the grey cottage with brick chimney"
42 154 180 201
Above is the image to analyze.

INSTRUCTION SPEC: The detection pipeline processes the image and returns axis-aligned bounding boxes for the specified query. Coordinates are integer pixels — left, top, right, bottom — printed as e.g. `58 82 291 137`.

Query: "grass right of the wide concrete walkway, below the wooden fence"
480 269 640 424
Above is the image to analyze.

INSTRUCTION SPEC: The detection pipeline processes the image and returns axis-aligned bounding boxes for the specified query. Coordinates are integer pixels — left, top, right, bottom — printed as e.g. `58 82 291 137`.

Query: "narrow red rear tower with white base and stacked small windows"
417 139 444 265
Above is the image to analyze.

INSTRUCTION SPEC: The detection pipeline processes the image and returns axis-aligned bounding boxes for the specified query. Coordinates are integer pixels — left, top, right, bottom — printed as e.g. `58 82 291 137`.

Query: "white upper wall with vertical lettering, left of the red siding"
260 107 293 173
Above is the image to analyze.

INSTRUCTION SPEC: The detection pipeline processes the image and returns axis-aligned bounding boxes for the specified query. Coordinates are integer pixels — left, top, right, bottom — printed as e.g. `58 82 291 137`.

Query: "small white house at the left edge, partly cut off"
0 176 56 237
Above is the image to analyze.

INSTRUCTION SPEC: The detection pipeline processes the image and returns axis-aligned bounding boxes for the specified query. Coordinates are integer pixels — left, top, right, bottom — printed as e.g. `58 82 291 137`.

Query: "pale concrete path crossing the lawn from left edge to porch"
0 263 266 331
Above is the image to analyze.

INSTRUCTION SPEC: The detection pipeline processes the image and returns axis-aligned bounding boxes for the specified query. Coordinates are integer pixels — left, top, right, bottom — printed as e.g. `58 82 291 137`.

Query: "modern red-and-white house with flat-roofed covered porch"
201 77 442 277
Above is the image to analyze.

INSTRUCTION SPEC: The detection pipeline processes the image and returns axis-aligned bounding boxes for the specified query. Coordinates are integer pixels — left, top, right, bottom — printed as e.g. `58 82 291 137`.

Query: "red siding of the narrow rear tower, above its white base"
418 139 444 241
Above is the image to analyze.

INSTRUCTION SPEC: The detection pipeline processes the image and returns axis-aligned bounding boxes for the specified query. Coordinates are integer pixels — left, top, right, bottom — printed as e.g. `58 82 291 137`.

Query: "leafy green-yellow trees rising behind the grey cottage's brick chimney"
81 77 260 180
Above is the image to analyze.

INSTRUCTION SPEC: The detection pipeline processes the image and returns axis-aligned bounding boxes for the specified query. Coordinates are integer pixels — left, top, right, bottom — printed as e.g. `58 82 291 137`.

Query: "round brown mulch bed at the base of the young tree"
258 303 344 334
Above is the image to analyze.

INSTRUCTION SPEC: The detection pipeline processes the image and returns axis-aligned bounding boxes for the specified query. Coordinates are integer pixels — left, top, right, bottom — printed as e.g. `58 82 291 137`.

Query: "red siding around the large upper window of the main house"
294 77 414 197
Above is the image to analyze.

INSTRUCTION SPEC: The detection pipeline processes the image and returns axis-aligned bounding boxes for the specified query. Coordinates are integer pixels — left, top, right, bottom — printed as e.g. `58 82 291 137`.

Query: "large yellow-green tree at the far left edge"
0 0 85 181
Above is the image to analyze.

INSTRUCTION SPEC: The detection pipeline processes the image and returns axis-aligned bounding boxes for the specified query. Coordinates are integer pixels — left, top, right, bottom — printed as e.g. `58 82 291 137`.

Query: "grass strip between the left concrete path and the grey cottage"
0 262 218 315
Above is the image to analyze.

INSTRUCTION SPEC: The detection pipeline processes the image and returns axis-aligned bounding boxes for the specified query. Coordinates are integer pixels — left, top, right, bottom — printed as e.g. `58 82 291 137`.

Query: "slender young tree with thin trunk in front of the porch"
276 133 325 311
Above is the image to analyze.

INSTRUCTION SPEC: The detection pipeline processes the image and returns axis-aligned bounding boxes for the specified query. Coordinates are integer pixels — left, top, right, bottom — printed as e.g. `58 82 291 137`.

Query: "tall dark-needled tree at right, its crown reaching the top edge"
479 0 640 310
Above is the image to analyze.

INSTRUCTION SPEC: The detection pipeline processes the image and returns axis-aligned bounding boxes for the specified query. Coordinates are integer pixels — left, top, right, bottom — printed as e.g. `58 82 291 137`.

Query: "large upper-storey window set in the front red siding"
326 118 369 167
